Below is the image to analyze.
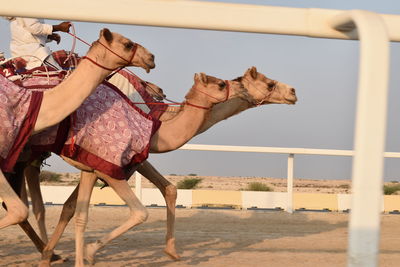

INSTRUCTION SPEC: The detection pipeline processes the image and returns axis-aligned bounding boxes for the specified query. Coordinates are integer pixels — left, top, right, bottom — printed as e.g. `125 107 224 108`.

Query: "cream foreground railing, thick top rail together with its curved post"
0 0 400 267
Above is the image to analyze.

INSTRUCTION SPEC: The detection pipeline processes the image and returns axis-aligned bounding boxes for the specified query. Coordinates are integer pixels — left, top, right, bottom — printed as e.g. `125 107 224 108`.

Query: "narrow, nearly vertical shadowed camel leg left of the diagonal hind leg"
25 165 48 243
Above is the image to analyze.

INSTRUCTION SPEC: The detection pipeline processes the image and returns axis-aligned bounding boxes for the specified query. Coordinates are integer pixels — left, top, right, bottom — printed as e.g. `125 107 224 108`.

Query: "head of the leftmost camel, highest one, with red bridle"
88 28 155 72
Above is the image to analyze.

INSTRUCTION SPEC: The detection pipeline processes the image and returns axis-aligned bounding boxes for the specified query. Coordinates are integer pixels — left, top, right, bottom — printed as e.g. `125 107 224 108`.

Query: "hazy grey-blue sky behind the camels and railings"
0 0 400 181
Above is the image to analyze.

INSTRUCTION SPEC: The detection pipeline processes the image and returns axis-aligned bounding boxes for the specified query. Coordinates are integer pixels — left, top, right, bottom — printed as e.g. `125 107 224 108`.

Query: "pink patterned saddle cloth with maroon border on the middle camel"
0 52 166 179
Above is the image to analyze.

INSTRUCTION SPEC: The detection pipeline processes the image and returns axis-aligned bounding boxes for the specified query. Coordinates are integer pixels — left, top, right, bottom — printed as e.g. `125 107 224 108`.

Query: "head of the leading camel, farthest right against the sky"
235 67 297 105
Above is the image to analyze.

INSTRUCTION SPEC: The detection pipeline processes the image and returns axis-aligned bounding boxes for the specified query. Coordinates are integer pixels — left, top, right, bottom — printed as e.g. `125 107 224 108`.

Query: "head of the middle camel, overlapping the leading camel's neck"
185 73 243 107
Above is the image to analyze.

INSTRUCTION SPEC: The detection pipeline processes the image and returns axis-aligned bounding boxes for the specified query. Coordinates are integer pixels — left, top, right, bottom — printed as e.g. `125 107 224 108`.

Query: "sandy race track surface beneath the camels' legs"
0 206 400 267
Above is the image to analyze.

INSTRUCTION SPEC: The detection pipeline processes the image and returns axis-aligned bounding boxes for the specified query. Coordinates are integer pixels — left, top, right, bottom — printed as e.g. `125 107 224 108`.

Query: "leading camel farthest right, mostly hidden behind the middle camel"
27 67 297 266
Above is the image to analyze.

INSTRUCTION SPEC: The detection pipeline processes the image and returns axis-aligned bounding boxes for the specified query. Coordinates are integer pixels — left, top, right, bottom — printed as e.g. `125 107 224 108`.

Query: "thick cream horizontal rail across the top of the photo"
0 0 400 42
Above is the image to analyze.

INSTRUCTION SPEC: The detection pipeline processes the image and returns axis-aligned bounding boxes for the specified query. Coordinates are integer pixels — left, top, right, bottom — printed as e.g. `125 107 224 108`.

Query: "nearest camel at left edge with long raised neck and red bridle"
0 29 155 258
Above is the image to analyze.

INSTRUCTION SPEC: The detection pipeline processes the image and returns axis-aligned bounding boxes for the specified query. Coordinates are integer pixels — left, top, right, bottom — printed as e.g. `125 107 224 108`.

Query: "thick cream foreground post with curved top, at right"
332 10 389 267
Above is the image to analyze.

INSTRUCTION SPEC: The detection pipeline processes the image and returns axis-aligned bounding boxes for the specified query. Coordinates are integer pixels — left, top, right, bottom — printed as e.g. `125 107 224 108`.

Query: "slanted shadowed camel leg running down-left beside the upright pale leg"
39 184 79 267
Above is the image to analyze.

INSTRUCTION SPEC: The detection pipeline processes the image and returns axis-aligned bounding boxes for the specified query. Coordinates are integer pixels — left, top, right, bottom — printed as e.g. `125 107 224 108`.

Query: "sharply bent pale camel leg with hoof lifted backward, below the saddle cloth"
85 175 148 264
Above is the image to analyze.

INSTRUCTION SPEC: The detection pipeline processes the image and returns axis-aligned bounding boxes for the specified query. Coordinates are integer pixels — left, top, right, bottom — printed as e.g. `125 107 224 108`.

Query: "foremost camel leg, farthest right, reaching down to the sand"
137 160 180 260
